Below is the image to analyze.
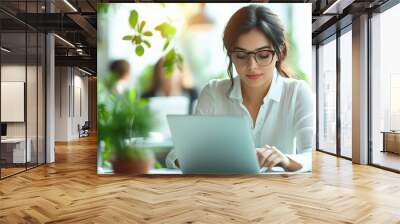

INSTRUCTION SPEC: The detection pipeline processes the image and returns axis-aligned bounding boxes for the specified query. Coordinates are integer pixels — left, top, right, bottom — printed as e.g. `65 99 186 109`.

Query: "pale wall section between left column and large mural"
55 67 89 141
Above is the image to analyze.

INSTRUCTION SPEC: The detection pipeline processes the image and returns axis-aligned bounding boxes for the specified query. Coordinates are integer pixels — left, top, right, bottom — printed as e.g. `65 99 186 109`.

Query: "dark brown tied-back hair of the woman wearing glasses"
223 5 291 85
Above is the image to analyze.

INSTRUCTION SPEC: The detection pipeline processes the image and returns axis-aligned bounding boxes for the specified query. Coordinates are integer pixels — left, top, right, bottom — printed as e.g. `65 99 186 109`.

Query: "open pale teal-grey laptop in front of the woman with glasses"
167 115 260 174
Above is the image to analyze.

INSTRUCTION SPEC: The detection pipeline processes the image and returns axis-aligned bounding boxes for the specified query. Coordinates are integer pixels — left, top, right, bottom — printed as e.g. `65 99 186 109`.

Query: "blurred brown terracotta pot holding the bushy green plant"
111 159 152 175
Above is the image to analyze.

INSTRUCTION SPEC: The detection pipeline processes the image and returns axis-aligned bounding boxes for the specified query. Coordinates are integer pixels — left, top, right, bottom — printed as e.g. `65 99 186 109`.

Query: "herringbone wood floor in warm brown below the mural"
0 137 400 224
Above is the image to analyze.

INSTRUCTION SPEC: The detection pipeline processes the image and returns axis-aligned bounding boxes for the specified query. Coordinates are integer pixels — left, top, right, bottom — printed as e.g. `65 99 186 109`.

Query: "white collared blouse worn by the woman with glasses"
166 70 315 172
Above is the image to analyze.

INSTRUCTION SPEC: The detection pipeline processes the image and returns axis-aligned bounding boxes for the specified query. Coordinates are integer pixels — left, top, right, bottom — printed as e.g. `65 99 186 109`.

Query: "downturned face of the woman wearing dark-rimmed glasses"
231 28 277 88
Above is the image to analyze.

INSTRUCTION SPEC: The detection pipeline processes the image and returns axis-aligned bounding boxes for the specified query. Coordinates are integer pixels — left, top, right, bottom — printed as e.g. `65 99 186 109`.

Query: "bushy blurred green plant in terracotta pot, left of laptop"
98 75 155 174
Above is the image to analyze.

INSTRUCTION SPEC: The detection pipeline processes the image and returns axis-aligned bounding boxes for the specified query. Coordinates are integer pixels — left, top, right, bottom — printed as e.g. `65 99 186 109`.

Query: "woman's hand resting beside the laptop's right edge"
256 145 302 171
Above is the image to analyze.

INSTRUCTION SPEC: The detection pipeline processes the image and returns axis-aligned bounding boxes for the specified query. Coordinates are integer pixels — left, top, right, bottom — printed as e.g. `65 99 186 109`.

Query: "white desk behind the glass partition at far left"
1 138 32 163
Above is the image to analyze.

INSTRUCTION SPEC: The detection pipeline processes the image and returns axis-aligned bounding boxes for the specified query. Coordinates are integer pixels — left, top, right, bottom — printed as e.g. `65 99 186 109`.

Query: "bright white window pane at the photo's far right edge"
371 4 400 170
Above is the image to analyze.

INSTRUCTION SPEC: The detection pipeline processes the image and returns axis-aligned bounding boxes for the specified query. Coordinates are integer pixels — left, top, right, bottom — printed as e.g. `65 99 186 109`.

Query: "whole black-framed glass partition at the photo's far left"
0 1 46 179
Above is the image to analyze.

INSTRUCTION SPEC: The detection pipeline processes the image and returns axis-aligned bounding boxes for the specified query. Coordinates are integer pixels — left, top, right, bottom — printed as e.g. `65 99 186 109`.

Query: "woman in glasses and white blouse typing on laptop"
166 5 314 172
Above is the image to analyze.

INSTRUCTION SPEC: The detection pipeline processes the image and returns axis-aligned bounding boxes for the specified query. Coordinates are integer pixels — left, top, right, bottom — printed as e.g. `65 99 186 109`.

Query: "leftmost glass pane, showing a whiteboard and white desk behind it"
0 32 30 178
